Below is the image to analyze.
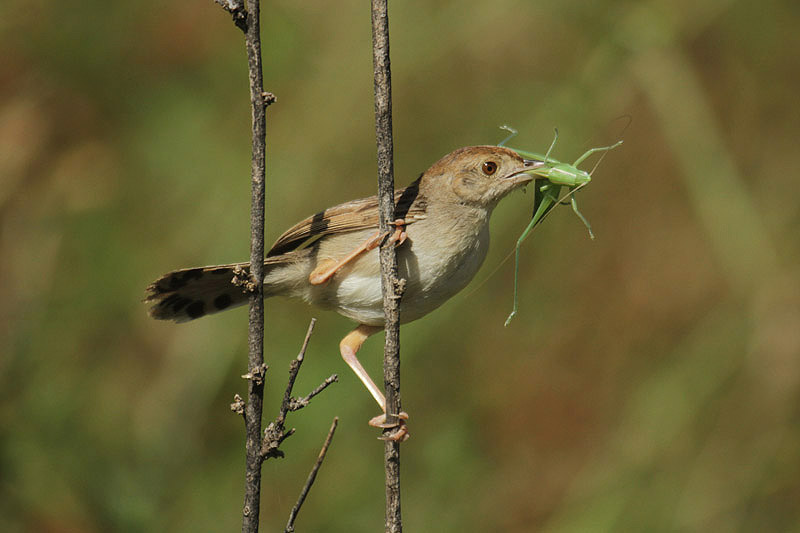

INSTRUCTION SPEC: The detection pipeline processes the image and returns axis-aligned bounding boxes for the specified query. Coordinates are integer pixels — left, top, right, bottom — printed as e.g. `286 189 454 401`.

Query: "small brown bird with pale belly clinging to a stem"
145 146 544 435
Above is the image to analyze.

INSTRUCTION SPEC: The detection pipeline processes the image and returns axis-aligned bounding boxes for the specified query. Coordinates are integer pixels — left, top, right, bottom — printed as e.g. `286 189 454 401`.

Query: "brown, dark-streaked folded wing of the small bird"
267 179 427 257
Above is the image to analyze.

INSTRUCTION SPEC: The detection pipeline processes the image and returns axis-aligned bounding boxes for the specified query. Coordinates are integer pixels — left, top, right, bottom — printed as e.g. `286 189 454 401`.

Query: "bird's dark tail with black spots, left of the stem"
144 263 250 322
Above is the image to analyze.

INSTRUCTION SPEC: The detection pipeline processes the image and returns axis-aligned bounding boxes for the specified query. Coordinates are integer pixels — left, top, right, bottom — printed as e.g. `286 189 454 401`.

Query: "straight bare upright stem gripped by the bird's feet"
372 0 403 533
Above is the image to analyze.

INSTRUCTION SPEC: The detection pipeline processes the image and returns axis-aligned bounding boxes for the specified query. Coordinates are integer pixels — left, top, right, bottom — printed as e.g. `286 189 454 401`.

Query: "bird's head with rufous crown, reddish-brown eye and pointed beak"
420 146 543 209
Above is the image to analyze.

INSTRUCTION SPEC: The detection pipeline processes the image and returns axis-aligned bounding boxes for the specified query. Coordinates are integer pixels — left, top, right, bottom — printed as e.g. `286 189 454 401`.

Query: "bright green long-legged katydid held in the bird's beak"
499 126 622 326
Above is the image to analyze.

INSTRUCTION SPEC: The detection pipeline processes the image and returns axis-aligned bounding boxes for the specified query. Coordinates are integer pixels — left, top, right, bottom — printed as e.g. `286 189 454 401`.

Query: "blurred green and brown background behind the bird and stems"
0 0 800 532
